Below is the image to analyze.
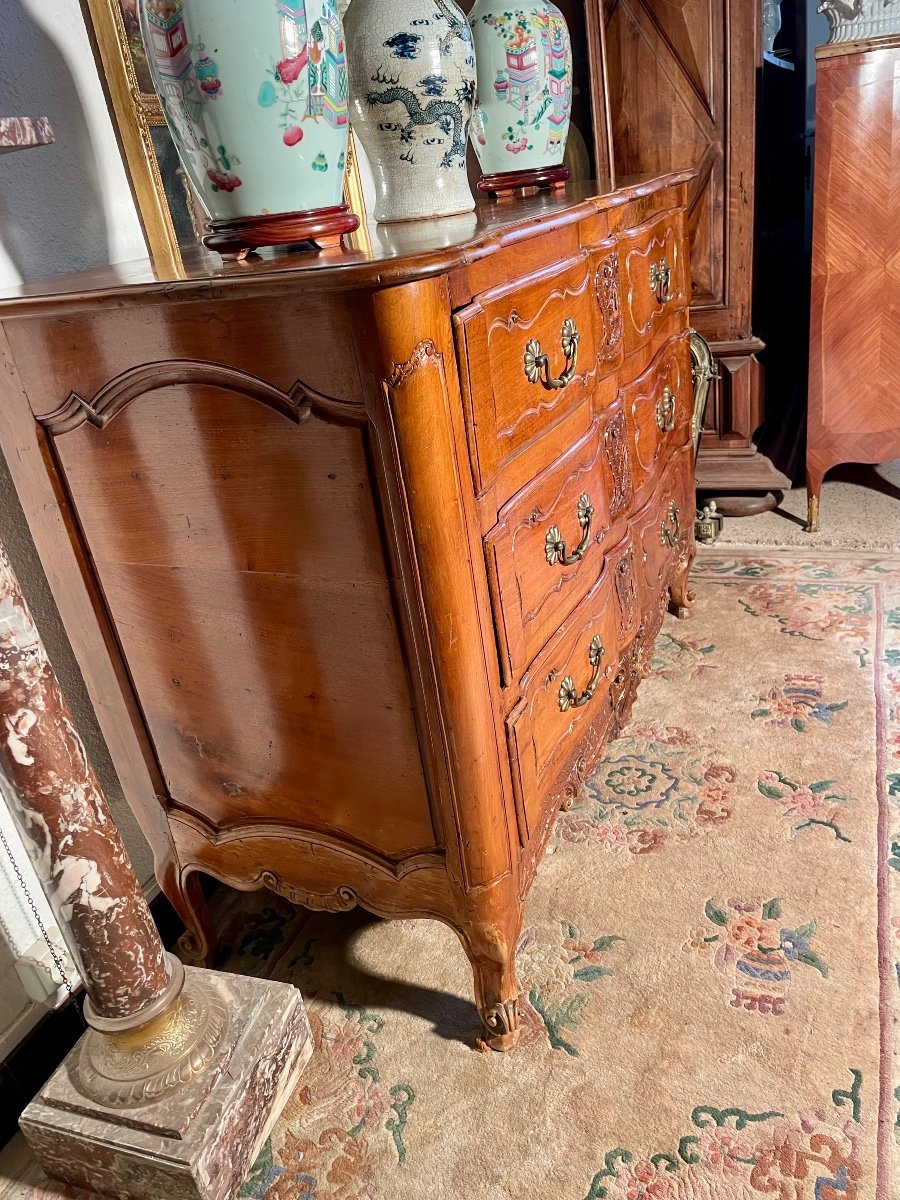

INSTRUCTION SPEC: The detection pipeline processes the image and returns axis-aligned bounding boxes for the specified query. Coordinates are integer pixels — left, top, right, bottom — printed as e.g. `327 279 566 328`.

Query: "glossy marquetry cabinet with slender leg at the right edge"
806 34 900 532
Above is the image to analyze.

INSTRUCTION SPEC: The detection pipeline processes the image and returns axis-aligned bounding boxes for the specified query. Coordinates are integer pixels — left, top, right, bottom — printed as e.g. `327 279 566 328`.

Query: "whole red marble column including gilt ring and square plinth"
0 546 312 1200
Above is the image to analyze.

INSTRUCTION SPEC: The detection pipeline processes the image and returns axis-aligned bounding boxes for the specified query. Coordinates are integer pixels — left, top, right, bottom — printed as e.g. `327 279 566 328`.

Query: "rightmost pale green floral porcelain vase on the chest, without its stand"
469 0 572 178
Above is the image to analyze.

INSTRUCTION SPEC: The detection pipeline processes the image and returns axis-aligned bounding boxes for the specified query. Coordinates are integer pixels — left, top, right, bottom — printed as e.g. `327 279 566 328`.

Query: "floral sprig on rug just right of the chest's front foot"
516 920 624 1057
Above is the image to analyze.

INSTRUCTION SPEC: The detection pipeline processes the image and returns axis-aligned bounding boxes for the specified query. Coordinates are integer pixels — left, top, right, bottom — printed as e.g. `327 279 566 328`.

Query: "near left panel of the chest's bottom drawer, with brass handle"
506 556 618 836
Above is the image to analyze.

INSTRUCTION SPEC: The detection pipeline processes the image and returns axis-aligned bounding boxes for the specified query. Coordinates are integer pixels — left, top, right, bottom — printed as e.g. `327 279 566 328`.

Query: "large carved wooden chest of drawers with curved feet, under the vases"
0 175 694 1049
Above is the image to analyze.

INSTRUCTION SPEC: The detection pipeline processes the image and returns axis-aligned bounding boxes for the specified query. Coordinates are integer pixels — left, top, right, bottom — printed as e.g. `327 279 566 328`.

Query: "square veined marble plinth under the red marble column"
19 967 312 1200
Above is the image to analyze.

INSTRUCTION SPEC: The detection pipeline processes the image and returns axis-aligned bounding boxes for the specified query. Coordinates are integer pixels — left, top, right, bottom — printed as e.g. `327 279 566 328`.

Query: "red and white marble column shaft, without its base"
0 548 170 1019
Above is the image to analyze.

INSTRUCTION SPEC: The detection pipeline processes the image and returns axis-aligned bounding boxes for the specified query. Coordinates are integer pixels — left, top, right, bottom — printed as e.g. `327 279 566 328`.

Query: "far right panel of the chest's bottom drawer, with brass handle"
631 446 695 608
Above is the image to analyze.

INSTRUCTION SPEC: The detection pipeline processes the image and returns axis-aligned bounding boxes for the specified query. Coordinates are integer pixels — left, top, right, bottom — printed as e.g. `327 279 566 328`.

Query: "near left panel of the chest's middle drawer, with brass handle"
485 418 610 683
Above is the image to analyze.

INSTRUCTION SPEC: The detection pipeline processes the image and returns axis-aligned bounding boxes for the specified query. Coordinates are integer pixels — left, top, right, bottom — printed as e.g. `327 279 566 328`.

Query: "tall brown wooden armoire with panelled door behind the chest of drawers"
586 0 788 491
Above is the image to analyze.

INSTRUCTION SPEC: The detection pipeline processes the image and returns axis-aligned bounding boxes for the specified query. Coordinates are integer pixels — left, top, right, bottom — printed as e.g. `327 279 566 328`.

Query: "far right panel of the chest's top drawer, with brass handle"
619 212 689 354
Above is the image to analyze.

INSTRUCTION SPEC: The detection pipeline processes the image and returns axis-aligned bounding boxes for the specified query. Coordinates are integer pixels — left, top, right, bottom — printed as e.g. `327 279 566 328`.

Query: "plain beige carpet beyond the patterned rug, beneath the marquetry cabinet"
716 461 900 552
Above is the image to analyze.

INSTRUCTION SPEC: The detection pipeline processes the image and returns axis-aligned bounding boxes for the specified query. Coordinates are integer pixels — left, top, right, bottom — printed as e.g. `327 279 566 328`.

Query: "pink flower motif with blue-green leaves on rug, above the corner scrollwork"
683 899 828 1016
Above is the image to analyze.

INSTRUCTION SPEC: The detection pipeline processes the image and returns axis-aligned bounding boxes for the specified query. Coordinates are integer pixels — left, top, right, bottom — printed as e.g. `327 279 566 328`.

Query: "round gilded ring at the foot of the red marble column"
78 971 228 1109
